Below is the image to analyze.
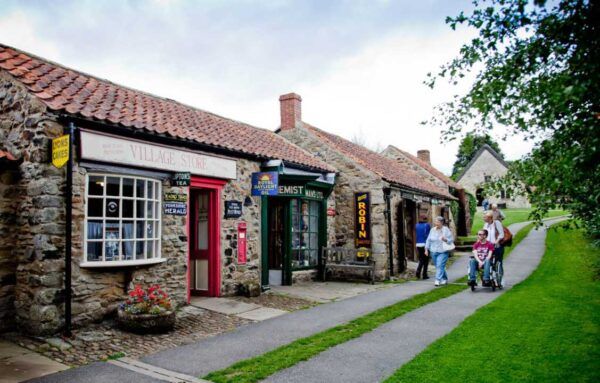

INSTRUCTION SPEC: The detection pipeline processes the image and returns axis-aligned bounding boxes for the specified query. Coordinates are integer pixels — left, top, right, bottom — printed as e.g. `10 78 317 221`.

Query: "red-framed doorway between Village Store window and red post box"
188 177 225 297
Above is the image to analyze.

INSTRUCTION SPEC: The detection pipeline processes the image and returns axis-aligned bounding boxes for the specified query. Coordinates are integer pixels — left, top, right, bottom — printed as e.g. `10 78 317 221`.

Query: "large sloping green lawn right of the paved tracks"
386 229 600 383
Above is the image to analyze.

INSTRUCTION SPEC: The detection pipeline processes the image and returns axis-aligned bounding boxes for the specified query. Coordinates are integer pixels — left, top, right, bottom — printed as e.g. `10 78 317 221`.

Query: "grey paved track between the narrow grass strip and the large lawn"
265 222 546 383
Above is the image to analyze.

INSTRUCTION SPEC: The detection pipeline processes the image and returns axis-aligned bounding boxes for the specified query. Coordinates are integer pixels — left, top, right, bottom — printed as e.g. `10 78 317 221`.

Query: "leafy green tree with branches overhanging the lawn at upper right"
426 0 600 237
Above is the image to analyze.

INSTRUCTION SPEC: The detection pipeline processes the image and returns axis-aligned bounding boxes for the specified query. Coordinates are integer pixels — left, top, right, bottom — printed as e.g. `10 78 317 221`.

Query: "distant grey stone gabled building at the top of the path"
457 144 531 208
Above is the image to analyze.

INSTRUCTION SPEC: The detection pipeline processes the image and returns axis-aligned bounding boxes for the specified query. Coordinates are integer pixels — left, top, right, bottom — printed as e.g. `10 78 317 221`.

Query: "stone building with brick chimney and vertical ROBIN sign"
278 93 456 279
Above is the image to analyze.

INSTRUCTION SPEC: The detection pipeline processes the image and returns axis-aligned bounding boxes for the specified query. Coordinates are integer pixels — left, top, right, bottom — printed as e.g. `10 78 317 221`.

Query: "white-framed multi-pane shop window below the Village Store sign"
82 174 162 266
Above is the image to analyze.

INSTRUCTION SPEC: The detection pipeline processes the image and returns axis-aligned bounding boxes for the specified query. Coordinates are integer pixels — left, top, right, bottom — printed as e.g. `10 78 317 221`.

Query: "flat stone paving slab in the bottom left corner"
0 340 69 383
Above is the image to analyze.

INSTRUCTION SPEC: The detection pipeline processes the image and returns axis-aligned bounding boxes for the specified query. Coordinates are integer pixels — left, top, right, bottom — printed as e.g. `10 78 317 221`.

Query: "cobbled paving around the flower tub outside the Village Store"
3 306 251 366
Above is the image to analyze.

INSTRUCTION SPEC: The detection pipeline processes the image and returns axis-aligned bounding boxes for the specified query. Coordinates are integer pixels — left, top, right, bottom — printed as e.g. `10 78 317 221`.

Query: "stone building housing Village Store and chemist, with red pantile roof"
0 45 335 334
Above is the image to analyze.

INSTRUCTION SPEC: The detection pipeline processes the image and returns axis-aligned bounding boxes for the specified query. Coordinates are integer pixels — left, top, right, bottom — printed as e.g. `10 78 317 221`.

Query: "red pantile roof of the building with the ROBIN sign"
303 123 456 199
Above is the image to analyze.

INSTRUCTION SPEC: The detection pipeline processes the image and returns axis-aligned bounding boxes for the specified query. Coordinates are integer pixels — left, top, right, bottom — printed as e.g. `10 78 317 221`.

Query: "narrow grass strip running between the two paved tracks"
203 224 533 383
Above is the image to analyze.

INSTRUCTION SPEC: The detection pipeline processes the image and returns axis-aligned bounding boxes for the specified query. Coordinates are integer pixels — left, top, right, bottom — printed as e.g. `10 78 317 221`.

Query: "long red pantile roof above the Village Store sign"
0 44 335 172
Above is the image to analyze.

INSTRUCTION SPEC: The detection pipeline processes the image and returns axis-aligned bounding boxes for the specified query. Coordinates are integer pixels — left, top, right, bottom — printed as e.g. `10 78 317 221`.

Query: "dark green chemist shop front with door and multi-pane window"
255 169 333 287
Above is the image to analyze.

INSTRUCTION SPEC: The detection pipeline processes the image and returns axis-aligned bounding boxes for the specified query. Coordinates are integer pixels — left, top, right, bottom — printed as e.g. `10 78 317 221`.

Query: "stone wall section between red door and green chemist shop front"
220 159 261 296
